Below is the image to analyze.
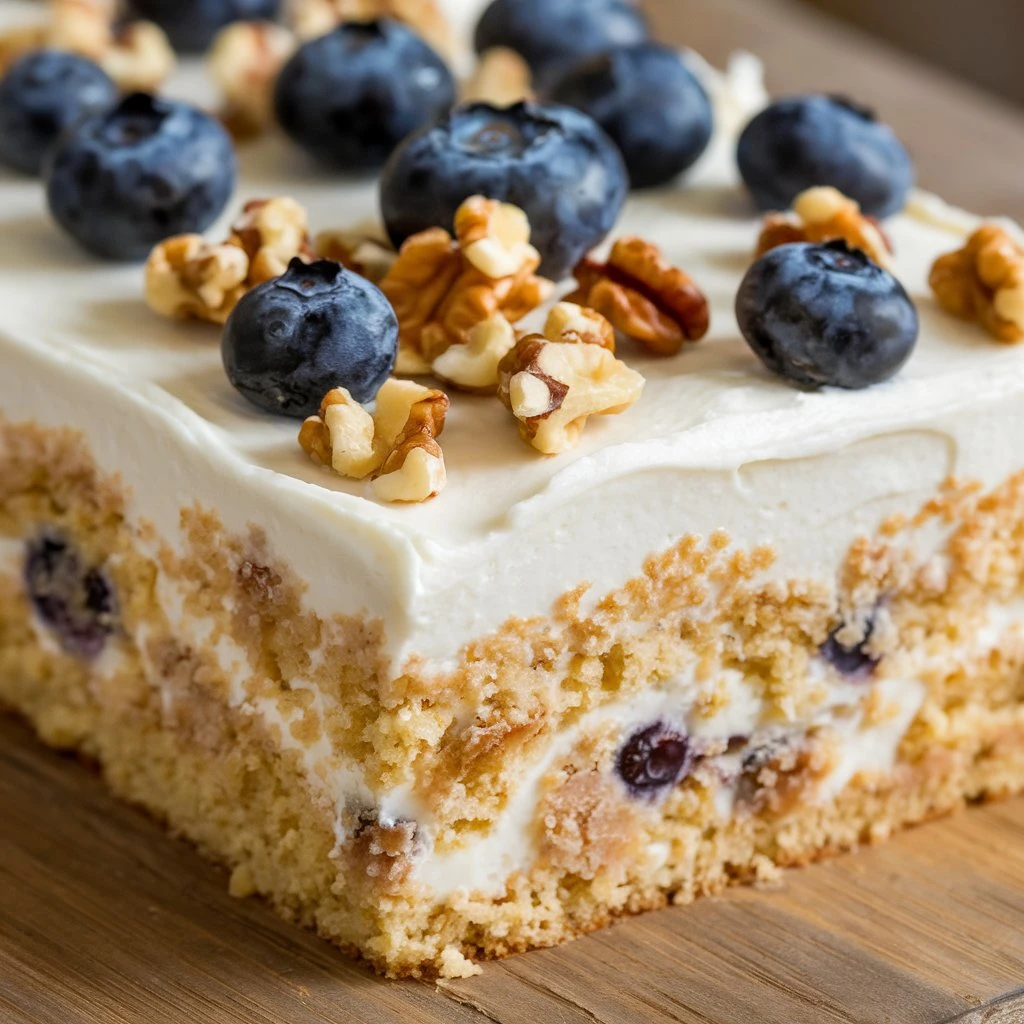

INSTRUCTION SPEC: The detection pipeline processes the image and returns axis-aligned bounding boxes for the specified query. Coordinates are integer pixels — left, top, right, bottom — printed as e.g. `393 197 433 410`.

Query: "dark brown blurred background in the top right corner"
798 0 1024 104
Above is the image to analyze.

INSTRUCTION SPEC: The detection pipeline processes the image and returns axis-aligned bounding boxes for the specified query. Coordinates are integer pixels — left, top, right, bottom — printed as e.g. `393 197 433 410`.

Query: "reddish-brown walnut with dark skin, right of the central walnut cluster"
567 238 711 355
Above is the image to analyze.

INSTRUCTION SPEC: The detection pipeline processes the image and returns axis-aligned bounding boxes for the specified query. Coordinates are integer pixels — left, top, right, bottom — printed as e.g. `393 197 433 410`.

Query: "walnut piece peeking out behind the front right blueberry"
757 185 892 270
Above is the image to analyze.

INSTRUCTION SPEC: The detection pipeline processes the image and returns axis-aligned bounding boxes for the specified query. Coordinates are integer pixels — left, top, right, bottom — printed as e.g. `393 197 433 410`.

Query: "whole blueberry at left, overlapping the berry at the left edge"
44 92 236 260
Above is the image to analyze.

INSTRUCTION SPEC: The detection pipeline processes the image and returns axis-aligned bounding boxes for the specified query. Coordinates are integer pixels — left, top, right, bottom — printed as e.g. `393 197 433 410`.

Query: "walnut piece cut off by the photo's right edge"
930 224 1024 344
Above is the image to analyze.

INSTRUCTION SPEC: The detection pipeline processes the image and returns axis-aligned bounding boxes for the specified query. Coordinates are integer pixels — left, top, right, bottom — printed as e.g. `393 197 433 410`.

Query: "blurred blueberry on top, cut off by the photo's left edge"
0 50 119 174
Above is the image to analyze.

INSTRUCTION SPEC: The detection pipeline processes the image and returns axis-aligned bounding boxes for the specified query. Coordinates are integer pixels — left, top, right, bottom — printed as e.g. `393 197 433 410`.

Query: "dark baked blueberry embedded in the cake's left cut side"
25 530 117 659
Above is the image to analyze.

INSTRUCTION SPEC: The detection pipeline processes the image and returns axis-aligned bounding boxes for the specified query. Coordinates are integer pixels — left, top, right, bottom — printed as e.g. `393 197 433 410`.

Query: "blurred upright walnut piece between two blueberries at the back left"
208 22 296 138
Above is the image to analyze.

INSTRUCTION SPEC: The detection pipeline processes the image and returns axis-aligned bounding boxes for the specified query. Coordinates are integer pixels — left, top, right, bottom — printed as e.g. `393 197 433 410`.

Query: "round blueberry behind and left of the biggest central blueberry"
274 19 456 171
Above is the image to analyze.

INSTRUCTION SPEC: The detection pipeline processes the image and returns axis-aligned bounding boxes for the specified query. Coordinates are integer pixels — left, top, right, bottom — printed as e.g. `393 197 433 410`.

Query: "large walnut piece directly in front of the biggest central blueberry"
380 196 554 376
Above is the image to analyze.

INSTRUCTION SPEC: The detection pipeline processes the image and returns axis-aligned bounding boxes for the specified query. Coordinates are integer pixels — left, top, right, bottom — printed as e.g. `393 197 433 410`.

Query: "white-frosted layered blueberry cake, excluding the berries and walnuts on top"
0 0 1024 976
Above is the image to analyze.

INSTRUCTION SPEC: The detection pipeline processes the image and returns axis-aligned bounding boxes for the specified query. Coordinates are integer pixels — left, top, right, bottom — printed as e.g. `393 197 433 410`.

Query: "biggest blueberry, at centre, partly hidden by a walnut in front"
381 103 629 281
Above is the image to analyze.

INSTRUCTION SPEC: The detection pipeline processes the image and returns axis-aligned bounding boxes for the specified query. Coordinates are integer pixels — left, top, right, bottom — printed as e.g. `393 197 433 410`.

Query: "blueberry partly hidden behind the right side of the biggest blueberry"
547 43 714 188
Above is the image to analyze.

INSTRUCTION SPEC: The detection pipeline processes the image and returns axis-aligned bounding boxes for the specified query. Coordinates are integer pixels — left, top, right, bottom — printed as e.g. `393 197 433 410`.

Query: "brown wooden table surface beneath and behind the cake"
6 0 1024 1024
